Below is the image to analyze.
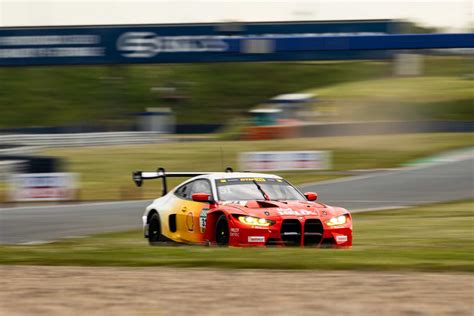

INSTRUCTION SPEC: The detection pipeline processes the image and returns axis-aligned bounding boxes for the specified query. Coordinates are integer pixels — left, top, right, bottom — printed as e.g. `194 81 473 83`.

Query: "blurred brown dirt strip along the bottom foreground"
0 266 474 316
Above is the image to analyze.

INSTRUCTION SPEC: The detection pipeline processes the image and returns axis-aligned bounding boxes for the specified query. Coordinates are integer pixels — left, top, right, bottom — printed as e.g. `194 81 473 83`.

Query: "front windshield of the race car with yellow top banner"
216 178 306 201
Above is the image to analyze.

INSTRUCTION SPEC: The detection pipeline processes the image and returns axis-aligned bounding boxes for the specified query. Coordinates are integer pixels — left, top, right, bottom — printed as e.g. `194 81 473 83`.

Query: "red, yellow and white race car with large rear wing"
133 168 352 248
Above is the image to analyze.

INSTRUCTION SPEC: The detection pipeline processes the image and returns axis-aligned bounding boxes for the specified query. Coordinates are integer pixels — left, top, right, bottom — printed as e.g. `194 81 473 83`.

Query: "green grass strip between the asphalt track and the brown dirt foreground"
0 201 474 272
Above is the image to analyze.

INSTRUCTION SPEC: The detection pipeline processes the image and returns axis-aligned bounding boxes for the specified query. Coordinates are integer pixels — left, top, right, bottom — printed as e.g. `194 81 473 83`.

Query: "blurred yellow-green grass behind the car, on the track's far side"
35 133 474 200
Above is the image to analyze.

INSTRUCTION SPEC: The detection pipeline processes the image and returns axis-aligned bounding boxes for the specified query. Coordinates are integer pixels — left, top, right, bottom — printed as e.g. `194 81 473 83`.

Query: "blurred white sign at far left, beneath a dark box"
9 173 78 202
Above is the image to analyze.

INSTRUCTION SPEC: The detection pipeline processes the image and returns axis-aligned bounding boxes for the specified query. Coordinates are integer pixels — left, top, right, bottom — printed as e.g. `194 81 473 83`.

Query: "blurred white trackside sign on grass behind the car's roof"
239 150 331 171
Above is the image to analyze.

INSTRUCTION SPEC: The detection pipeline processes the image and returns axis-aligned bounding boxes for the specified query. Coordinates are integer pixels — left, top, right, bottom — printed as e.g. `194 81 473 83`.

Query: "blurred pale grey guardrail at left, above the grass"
0 132 167 147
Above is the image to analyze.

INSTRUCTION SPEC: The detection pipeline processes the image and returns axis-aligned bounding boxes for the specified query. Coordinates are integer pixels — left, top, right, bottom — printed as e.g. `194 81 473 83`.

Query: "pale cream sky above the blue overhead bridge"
0 0 474 32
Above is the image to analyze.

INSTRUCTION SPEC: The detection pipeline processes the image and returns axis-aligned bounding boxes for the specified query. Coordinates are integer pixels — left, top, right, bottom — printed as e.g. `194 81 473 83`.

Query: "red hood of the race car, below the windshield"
218 200 347 218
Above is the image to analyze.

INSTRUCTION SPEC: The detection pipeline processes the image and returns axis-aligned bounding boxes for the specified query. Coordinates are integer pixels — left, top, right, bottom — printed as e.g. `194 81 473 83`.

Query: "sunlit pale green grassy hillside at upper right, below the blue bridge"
309 76 474 121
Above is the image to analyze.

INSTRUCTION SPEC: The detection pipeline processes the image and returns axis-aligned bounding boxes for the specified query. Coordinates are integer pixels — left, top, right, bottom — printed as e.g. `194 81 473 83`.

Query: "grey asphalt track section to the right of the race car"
301 151 474 211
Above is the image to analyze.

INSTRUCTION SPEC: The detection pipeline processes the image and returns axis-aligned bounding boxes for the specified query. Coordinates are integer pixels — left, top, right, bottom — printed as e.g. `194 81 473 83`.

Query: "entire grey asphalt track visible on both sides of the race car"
0 150 474 244
